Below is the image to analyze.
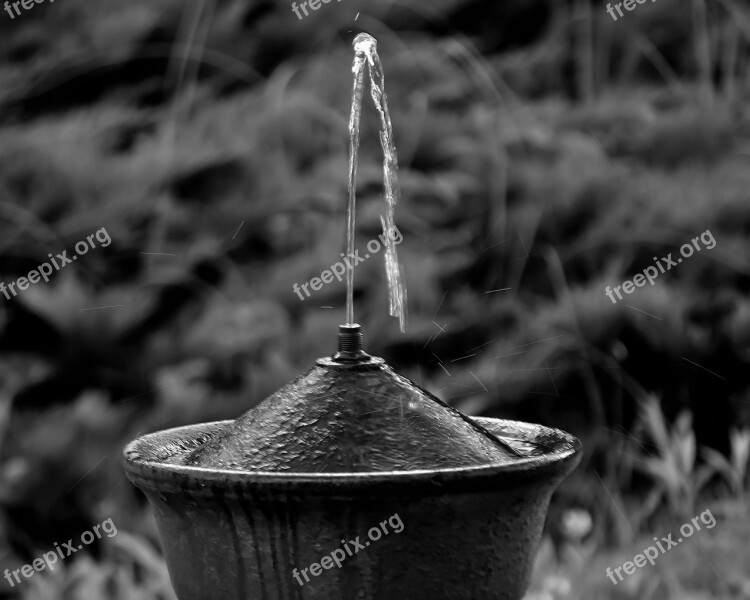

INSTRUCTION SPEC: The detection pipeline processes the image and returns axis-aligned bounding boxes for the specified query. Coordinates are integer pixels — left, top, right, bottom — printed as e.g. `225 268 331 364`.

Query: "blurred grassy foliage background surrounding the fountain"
0 0 750 600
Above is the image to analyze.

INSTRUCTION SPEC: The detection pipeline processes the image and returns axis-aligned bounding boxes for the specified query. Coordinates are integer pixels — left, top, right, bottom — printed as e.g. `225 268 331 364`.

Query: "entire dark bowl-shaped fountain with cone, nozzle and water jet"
124 34 581 600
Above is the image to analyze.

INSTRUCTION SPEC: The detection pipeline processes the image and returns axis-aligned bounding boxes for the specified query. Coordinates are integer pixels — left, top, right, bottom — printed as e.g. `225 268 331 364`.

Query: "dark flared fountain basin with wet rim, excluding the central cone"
123 418 581 600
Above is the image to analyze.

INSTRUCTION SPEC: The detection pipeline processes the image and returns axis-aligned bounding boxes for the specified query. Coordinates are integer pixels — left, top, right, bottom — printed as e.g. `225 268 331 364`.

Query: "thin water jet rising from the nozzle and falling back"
346 33 406 332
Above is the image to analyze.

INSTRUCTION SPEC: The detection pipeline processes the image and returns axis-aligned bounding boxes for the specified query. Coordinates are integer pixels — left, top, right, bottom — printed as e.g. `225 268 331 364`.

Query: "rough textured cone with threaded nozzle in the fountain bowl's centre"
181 325 518 473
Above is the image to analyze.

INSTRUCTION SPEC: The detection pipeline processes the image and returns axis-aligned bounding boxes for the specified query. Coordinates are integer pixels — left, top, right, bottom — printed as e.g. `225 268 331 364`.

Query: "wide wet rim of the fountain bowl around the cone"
122 417 582 496
